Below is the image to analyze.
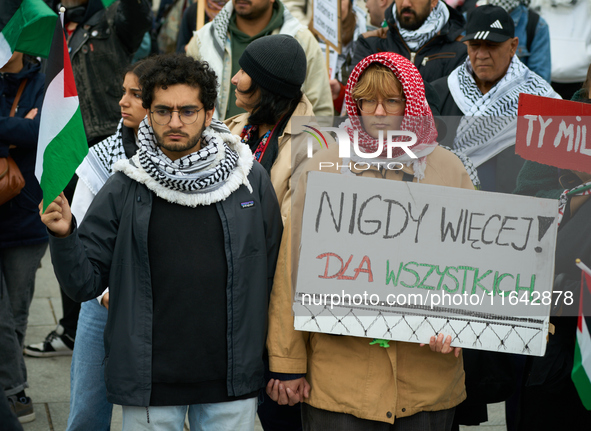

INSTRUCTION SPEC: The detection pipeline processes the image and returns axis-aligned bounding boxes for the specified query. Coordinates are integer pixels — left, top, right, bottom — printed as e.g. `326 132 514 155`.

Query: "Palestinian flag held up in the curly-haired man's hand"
35 19 88 211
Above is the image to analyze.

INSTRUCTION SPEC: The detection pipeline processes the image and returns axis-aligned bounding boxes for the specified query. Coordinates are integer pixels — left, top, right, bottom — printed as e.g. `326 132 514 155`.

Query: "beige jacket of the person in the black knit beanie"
224 96 314 224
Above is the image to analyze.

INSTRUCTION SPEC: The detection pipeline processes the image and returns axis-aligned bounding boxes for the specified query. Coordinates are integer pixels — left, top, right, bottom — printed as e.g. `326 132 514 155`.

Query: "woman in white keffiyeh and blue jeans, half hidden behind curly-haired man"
57 59 150 431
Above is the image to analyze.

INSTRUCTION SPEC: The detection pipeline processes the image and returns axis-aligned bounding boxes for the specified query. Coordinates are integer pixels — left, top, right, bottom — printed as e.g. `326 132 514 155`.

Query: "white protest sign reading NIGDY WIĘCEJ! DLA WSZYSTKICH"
294 172 569 356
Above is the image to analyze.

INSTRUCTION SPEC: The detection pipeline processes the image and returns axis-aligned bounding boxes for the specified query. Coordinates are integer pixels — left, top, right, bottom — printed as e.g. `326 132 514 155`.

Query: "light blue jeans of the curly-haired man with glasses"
123 397 257 431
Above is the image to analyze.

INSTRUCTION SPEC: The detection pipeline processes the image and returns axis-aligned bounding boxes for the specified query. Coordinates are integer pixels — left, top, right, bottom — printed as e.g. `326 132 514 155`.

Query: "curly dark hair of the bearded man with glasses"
138 54 218 111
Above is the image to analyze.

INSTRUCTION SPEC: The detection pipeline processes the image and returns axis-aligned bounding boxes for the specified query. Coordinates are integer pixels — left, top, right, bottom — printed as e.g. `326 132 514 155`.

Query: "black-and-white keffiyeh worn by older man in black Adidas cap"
447 55 560 167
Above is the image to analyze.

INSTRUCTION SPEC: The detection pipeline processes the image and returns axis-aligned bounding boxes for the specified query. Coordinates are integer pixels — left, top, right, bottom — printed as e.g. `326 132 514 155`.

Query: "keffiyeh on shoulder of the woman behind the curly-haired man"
76 120 127 195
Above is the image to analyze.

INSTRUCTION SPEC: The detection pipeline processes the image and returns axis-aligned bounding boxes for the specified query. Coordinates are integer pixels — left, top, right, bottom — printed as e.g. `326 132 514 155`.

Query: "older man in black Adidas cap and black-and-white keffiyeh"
433 5 560 193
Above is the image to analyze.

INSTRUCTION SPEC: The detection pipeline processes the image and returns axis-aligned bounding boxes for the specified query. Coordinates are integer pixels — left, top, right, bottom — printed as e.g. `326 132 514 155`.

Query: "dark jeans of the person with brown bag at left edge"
0 242 47 396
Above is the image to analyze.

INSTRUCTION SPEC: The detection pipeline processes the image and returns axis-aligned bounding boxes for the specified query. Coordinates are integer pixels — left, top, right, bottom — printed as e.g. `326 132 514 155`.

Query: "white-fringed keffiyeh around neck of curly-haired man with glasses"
114 119 253 207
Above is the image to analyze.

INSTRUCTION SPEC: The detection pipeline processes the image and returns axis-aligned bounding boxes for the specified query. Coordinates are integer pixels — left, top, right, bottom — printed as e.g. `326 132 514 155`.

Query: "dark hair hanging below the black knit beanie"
237 81 303 126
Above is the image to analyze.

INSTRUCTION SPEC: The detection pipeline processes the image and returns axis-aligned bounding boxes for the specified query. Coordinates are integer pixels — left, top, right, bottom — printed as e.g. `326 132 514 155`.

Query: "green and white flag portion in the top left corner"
0 0 57 67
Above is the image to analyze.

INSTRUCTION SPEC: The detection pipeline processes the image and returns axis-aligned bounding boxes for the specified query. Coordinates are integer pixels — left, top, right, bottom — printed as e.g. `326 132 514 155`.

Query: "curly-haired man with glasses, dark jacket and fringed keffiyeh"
41 55 282 430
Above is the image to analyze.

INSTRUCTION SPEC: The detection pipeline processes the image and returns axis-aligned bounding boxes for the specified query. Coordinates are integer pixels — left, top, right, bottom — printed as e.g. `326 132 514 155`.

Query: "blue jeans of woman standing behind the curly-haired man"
67 299 113 431
